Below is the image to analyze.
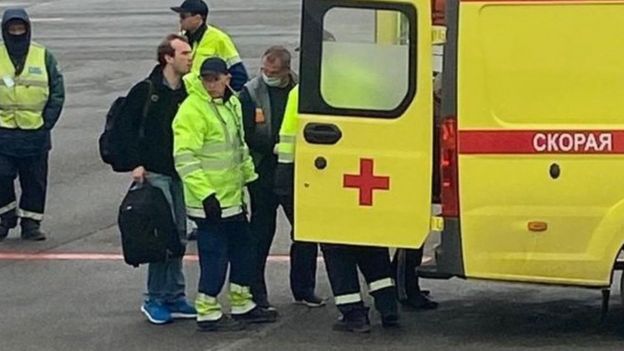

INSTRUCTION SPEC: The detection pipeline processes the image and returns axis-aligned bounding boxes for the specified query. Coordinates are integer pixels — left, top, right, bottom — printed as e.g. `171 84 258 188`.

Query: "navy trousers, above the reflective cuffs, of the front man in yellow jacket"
196 214 255 297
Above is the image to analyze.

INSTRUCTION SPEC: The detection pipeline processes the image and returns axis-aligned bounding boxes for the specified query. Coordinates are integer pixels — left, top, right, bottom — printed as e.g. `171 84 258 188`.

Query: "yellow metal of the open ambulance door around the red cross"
295 0 433 248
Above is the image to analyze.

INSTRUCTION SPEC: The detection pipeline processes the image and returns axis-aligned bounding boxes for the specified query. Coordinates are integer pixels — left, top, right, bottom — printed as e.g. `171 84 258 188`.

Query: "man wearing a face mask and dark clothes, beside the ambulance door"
240 46 325 309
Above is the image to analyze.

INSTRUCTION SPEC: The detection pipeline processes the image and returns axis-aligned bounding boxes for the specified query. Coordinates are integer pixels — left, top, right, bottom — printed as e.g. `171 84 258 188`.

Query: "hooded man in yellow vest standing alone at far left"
0 9 65 240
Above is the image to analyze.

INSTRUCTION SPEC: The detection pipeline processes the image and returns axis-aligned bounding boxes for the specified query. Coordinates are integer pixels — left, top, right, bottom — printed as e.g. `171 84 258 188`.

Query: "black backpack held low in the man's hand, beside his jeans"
117 180 185 267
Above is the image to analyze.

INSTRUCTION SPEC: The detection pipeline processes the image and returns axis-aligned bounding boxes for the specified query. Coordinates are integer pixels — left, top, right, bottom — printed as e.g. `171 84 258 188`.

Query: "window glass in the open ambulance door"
320 7 410 111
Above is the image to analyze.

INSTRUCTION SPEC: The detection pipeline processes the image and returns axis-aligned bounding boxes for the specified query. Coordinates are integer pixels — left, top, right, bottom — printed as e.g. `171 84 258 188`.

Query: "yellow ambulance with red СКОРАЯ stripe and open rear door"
295 0 624 288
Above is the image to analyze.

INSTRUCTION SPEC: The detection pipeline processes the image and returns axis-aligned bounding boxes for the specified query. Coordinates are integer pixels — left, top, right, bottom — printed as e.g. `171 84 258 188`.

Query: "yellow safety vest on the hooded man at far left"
0 43 50 130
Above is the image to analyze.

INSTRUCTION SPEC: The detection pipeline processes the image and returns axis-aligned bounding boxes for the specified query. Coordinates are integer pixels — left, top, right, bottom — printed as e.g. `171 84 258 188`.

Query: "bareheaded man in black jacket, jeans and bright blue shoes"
124 34 196 324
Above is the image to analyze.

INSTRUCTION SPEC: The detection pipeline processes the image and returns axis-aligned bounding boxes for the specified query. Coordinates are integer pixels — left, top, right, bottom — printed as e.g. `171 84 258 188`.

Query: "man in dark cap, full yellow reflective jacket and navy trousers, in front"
173 57 277 331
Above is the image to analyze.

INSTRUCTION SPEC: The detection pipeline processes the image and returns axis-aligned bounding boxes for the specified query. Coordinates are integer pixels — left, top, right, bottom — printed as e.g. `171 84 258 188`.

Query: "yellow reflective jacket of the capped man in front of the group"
173 74 258 218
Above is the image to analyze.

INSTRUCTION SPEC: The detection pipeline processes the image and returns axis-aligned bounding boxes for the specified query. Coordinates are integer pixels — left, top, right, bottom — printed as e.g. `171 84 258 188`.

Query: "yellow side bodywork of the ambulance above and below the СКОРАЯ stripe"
458 1 624 286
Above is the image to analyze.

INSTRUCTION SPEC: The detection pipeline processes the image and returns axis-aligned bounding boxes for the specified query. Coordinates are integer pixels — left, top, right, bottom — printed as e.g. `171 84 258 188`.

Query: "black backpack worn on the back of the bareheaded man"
98 79 154 172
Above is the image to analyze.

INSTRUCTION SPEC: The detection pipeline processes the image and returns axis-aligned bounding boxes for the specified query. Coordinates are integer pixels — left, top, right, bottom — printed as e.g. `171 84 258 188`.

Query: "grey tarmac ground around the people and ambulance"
0 0 624 351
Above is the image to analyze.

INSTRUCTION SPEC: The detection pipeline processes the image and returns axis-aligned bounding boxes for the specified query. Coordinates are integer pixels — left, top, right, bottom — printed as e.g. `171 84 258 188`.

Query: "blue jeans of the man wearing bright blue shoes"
146 173 186 303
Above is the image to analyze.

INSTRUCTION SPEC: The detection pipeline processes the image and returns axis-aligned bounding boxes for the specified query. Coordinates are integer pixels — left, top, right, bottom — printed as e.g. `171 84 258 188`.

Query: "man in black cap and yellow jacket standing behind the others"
171 0 249 91
